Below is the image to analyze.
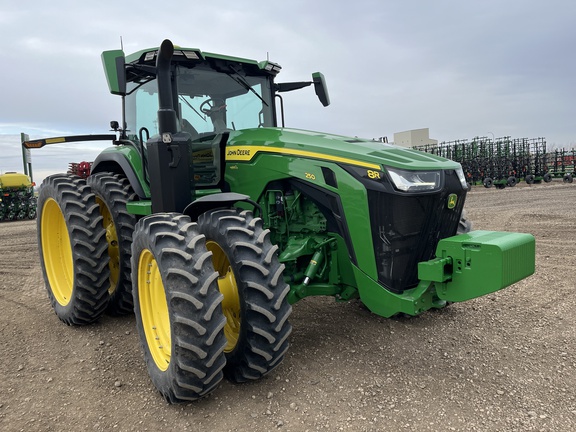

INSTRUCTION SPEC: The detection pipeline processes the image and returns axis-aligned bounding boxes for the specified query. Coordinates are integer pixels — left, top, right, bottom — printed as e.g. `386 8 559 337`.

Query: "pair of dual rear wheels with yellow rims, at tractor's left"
37 173 136 325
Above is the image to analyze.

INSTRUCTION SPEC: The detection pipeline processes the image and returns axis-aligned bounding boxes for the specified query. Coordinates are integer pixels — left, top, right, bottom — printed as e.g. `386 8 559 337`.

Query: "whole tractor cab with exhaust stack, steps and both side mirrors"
100 41 329 211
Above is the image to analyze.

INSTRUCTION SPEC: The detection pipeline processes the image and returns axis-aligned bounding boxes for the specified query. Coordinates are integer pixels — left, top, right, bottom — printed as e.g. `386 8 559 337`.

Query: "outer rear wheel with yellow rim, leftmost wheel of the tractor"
37 174 110 325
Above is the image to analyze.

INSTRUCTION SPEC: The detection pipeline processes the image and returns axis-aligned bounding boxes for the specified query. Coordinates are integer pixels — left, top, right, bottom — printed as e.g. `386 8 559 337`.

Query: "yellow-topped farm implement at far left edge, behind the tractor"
0 172 36 222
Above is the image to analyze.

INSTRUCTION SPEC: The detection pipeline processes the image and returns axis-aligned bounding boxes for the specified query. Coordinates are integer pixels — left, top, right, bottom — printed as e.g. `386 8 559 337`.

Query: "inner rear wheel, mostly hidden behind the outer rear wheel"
87 173 136 315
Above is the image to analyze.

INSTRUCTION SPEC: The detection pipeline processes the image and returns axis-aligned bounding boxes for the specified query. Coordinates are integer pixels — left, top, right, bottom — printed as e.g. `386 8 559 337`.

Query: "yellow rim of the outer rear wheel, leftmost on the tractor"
40 198 74 306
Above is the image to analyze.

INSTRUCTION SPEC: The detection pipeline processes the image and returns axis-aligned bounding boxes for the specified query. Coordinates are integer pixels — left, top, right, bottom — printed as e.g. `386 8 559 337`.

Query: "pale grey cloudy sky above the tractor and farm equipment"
0 0 576 182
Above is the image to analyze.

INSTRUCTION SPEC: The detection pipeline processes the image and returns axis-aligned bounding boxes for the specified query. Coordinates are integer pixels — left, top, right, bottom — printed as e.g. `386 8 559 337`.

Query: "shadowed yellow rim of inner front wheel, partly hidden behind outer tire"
206 241 241 353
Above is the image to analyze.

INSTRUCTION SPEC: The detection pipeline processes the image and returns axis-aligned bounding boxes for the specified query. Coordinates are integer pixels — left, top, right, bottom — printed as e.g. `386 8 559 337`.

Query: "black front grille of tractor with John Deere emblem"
365 170 466 293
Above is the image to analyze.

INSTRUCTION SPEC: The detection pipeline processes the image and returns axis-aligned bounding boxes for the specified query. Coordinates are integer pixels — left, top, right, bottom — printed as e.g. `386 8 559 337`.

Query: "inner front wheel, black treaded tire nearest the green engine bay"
198 209 292 382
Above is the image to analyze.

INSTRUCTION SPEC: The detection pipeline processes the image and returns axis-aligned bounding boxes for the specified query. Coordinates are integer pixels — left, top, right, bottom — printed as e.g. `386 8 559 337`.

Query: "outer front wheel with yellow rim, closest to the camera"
132 214 226 403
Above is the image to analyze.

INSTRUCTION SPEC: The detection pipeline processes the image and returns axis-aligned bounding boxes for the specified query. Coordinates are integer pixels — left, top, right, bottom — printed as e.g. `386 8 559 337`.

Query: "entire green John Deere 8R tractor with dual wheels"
24 40 535 403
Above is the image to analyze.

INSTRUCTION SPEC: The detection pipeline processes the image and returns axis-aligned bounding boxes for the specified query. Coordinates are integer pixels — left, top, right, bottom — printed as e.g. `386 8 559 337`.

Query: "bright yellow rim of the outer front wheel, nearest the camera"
138 249 172 371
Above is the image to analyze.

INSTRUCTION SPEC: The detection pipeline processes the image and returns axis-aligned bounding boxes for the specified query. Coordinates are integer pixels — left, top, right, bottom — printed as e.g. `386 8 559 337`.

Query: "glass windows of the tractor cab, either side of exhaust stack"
126 65 274 140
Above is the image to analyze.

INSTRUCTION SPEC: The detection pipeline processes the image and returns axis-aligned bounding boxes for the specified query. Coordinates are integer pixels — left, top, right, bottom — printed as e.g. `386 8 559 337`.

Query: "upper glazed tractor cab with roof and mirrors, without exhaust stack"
102 42 330 140
